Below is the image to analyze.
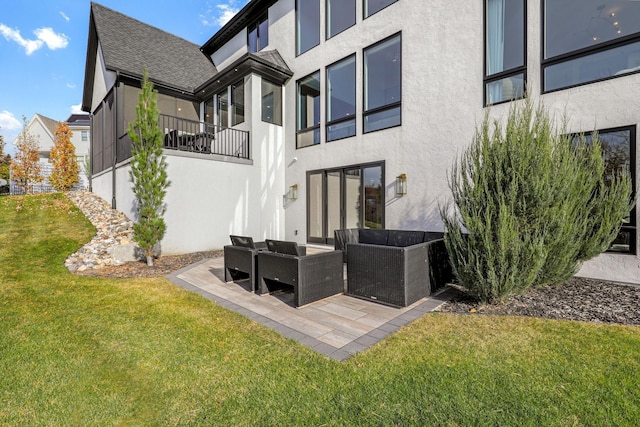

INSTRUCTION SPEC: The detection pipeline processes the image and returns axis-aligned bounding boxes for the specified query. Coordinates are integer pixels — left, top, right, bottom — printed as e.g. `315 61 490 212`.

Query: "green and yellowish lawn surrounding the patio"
0 195 640 426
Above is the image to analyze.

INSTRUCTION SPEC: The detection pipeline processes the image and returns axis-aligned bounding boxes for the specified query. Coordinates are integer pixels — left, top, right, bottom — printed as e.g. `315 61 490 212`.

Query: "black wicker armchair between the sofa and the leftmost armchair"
257 240 344 307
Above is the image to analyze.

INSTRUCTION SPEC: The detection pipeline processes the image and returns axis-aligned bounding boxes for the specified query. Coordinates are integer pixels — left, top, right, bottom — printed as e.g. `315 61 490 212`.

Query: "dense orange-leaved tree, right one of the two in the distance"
49 122 79 191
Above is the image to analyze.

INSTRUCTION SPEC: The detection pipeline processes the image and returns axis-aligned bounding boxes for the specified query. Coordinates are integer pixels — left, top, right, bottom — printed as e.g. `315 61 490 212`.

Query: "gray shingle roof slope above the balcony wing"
91 3 216 92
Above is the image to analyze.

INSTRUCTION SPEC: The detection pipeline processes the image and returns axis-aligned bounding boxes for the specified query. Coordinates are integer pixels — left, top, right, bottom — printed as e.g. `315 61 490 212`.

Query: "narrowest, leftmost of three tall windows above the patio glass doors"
296 71 320 148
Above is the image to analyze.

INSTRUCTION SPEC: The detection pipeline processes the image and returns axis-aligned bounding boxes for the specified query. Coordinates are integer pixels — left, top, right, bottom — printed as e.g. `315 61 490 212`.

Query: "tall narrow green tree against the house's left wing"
128 69 170 266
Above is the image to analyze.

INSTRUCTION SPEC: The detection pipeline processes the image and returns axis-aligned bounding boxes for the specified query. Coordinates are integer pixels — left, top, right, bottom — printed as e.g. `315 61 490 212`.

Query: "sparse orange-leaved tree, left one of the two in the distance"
11 116 44 193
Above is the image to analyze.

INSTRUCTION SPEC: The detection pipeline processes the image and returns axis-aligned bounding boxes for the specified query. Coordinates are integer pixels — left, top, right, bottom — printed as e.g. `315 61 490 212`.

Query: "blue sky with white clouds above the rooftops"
0 0 249 154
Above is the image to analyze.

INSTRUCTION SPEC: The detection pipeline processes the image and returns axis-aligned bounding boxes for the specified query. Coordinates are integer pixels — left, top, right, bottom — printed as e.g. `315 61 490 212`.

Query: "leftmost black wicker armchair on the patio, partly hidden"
224 235 267 292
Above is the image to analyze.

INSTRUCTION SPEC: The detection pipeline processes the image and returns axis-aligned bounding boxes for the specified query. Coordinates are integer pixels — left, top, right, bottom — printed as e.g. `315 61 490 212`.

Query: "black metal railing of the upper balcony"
159 114 251 159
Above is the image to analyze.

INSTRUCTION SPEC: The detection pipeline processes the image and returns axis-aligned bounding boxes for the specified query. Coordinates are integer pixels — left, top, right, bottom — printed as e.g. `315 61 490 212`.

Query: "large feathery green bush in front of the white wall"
441 100 631 302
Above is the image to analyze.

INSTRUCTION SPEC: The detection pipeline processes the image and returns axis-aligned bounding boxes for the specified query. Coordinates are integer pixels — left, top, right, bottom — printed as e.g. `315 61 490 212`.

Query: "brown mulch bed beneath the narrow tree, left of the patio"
76 250 223 278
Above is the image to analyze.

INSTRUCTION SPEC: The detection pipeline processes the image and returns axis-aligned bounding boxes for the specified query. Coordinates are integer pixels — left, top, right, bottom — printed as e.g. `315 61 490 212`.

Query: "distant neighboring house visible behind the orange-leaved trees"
13 113 91 190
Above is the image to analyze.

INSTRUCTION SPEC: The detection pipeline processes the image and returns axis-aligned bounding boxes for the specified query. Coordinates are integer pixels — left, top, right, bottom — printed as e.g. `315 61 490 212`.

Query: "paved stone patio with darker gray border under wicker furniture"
168 246 453 360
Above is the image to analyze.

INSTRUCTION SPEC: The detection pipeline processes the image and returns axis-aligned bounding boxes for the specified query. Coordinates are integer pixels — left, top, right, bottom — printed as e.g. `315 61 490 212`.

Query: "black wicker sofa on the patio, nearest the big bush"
334 229 453 307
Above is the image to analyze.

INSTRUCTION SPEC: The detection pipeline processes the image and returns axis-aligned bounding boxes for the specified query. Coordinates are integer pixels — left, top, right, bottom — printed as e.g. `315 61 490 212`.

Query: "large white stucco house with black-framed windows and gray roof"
82 0 640 283
